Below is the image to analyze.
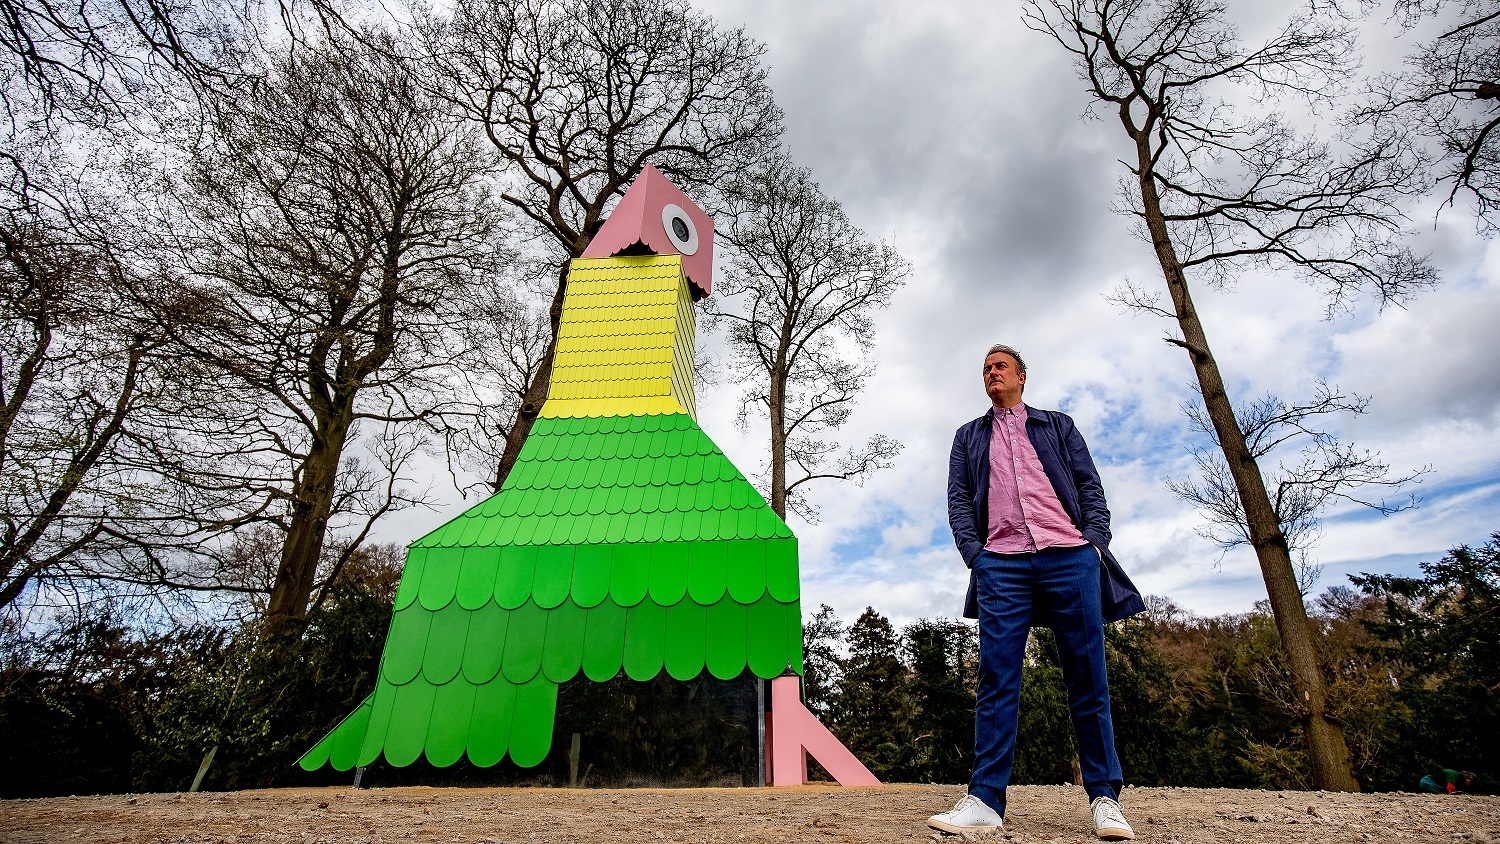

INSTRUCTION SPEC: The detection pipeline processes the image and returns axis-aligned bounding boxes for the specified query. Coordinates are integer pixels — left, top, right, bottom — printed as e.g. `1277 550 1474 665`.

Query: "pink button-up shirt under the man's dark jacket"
984 403 1089 553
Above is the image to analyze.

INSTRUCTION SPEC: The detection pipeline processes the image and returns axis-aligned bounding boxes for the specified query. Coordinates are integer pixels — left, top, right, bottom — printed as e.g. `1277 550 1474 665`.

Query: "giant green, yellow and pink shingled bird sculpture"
299 165 810 780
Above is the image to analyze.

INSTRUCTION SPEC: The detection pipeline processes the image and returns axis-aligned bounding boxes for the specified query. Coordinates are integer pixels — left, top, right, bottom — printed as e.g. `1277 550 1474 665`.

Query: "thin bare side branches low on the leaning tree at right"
1167 382 1428 597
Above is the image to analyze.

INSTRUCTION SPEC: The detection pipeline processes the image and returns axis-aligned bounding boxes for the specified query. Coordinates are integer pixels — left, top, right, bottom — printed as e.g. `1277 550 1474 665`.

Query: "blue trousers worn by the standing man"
969 546 1124 816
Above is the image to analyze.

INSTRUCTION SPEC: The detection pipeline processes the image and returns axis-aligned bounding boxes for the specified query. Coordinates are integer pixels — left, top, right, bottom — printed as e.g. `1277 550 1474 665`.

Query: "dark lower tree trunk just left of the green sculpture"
266 396 354 639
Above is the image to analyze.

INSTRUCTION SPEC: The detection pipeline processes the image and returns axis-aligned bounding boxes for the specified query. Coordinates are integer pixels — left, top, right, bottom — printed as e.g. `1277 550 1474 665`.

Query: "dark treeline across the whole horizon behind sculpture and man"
0 534 1500 798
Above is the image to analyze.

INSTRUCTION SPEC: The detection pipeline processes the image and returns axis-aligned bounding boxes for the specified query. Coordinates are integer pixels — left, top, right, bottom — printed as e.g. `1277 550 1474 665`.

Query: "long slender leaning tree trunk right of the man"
1133 132 1359 792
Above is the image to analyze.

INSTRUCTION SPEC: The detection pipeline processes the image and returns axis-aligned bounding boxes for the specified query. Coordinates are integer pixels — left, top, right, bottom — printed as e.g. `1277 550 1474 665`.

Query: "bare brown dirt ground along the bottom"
0 786 1500 844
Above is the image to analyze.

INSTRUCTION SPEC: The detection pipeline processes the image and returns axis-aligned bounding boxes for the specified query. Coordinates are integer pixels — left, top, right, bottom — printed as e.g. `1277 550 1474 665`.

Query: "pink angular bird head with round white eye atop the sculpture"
584 165 714 300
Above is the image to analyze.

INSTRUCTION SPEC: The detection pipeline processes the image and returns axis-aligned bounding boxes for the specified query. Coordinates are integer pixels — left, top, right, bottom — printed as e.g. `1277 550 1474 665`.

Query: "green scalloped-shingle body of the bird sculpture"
300 401 803 769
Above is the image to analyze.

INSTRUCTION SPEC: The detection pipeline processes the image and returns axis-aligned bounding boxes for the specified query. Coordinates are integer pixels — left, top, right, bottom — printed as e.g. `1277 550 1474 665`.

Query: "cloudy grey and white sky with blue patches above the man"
390 0 1500 635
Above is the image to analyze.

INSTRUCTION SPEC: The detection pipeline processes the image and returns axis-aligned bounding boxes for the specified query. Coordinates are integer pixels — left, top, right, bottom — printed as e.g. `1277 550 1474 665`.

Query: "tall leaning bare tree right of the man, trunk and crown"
1023 0 1436 790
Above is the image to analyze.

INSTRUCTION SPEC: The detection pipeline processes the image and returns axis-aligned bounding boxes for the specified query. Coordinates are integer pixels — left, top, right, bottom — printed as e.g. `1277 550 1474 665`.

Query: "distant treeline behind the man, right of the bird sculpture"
806 534 1500 793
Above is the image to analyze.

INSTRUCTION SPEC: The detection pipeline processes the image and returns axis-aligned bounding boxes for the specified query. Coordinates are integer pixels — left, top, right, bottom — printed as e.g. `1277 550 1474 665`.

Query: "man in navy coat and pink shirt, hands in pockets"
927 345 1146 840
